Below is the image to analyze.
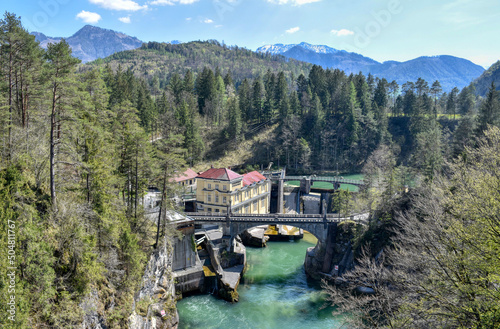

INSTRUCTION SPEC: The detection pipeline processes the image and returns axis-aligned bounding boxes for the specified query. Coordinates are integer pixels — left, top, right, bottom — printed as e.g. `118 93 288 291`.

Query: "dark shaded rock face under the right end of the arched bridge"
304 221 356 280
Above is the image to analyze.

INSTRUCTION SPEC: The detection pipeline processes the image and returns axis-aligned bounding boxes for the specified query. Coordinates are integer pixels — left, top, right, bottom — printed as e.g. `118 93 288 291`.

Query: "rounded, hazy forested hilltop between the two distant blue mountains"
86 40 312 90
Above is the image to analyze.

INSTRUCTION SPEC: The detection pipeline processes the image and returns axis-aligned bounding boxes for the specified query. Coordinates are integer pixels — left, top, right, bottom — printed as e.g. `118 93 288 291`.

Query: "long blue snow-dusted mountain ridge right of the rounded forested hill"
257 42 484 91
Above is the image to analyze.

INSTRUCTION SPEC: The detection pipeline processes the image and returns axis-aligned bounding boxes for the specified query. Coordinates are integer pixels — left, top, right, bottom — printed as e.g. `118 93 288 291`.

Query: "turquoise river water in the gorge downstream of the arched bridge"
177 234 345 329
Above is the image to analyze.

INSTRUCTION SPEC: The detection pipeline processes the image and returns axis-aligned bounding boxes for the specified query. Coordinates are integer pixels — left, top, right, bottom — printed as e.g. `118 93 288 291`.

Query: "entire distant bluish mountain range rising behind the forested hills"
32 25 485 91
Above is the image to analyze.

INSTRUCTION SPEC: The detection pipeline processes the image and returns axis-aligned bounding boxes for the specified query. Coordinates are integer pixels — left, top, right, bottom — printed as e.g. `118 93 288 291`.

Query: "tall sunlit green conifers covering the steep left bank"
0 13 184 328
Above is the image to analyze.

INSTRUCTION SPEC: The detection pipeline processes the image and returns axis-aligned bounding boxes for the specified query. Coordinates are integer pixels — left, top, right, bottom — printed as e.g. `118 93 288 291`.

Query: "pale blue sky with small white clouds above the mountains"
0 0 500 67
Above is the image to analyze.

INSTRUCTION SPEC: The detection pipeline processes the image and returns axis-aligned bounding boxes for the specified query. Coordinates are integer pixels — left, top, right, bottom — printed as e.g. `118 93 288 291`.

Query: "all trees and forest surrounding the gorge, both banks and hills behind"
0 13 500 328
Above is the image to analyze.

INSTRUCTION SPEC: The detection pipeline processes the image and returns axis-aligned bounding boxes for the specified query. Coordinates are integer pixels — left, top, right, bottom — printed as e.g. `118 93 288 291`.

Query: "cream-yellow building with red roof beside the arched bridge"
196 168 271 214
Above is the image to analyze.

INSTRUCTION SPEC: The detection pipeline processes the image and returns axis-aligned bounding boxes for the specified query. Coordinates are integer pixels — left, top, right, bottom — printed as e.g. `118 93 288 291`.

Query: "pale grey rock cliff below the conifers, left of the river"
129 241 179 329
